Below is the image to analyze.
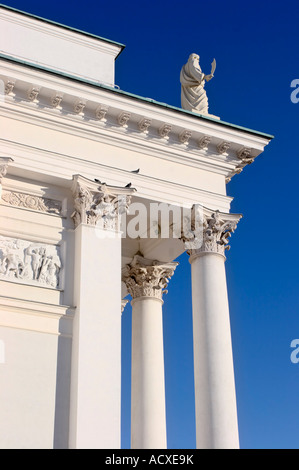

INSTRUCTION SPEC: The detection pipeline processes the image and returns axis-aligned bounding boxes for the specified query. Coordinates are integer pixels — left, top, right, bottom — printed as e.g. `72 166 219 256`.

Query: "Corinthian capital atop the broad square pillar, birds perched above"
72 175 135 230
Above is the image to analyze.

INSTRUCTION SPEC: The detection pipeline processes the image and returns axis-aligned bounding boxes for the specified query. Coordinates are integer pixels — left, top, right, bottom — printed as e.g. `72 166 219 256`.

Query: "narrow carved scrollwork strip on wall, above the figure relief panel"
2 190 62 215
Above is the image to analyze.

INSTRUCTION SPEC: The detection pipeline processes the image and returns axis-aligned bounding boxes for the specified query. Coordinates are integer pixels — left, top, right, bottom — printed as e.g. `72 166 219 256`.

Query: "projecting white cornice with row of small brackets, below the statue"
0 60 269 184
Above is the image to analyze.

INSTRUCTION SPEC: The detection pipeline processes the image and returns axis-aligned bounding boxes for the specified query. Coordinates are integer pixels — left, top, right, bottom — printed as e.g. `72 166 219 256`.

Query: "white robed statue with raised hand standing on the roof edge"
180 54 216 115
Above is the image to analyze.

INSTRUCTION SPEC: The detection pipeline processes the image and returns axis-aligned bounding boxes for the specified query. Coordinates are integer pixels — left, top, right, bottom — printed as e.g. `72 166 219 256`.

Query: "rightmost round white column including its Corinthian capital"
185 210 241 449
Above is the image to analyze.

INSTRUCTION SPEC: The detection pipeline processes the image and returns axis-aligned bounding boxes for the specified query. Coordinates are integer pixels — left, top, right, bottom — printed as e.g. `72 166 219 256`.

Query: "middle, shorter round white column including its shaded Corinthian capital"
123 255 178 449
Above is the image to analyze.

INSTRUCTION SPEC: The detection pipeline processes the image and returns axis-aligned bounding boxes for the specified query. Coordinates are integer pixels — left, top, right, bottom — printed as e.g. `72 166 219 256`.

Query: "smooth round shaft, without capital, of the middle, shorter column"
131 297 166 449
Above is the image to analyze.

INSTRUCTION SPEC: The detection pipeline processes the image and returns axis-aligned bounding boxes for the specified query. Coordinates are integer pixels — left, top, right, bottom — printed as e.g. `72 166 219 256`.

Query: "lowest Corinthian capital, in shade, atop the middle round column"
122 255 178 300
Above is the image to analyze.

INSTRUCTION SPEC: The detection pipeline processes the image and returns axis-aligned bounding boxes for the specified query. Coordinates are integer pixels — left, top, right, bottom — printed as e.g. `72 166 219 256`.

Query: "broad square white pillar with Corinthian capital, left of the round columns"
69 175 134 449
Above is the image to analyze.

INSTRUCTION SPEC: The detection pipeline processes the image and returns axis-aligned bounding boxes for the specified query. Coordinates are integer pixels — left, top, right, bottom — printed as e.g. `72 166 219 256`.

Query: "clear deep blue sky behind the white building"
3 0 299 449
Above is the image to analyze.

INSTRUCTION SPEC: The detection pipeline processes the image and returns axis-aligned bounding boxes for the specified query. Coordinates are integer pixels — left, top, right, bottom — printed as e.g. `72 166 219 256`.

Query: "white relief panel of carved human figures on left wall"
0 236 61 289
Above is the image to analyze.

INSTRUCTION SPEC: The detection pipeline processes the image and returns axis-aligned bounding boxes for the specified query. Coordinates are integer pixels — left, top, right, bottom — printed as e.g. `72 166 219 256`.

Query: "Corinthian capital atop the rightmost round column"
181 208 242 256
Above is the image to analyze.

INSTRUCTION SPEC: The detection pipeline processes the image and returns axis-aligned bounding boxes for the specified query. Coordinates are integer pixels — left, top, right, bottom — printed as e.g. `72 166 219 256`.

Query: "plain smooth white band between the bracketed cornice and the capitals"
0 139 233 211
